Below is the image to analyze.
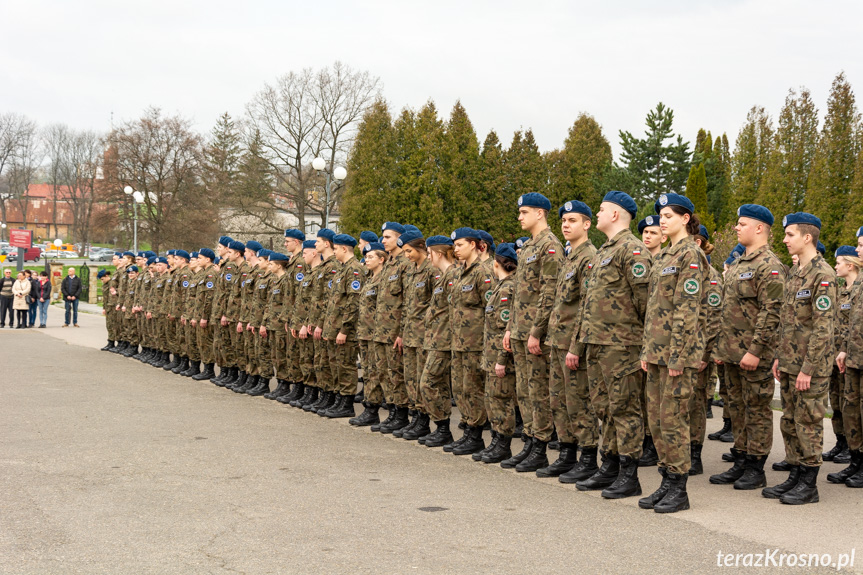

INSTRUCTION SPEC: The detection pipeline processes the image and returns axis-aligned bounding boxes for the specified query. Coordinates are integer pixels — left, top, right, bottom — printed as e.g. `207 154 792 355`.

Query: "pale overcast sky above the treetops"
0 0 863 158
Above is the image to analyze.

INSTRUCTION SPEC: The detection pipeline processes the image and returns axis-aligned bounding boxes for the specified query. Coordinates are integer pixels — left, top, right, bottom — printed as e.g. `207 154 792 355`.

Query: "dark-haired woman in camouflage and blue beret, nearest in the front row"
640 194 708 513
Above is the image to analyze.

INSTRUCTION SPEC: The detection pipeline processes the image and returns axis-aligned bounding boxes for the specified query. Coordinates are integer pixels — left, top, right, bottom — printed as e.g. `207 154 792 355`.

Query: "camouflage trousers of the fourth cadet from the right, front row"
510 339 554 442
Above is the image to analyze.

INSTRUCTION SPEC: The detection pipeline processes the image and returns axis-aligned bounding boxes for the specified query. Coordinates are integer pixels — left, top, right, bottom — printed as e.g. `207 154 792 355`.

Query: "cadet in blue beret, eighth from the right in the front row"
393 229 436 441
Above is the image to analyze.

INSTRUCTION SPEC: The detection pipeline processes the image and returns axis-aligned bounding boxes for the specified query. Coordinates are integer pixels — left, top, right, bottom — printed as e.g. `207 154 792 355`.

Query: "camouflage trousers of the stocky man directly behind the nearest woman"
585 344 647 459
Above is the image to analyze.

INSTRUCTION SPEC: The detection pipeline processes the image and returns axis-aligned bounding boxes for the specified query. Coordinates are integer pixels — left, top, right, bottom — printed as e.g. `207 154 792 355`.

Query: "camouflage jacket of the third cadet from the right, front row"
545 241 596 355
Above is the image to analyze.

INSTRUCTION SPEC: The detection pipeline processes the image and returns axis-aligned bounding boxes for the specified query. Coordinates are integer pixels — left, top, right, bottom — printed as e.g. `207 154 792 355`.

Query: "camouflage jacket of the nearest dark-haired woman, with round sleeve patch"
641 236 710 369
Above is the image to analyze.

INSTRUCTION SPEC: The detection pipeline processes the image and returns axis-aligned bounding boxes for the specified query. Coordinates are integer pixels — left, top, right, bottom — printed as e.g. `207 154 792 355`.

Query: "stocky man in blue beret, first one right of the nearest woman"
710 204 785 490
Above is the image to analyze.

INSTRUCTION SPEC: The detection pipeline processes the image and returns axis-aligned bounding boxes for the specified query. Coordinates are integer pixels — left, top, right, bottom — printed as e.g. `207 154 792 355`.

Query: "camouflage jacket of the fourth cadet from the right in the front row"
507 228 563 341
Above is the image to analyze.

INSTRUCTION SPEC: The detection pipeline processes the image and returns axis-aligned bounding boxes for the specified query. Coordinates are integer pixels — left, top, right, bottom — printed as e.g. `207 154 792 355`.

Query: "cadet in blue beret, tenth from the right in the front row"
348 243 387 427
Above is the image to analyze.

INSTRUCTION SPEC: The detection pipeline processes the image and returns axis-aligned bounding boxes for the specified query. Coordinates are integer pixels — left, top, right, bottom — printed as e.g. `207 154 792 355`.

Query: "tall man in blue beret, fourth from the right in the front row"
500 192 563 472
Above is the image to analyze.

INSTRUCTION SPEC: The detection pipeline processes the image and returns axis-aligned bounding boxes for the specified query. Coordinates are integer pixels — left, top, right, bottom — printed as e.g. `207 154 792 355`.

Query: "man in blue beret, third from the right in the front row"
536 200 599 483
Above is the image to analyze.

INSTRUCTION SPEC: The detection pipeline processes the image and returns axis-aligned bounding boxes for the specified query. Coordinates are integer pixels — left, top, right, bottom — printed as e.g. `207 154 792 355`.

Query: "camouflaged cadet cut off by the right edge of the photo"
840 227 863 489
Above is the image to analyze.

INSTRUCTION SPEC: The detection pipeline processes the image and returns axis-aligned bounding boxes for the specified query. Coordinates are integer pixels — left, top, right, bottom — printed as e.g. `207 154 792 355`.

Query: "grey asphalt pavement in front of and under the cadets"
0 308 863 575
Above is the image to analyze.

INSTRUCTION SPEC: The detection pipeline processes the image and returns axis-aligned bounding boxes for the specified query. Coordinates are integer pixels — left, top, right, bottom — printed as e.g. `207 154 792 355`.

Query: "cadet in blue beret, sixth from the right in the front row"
444 228 491 455
